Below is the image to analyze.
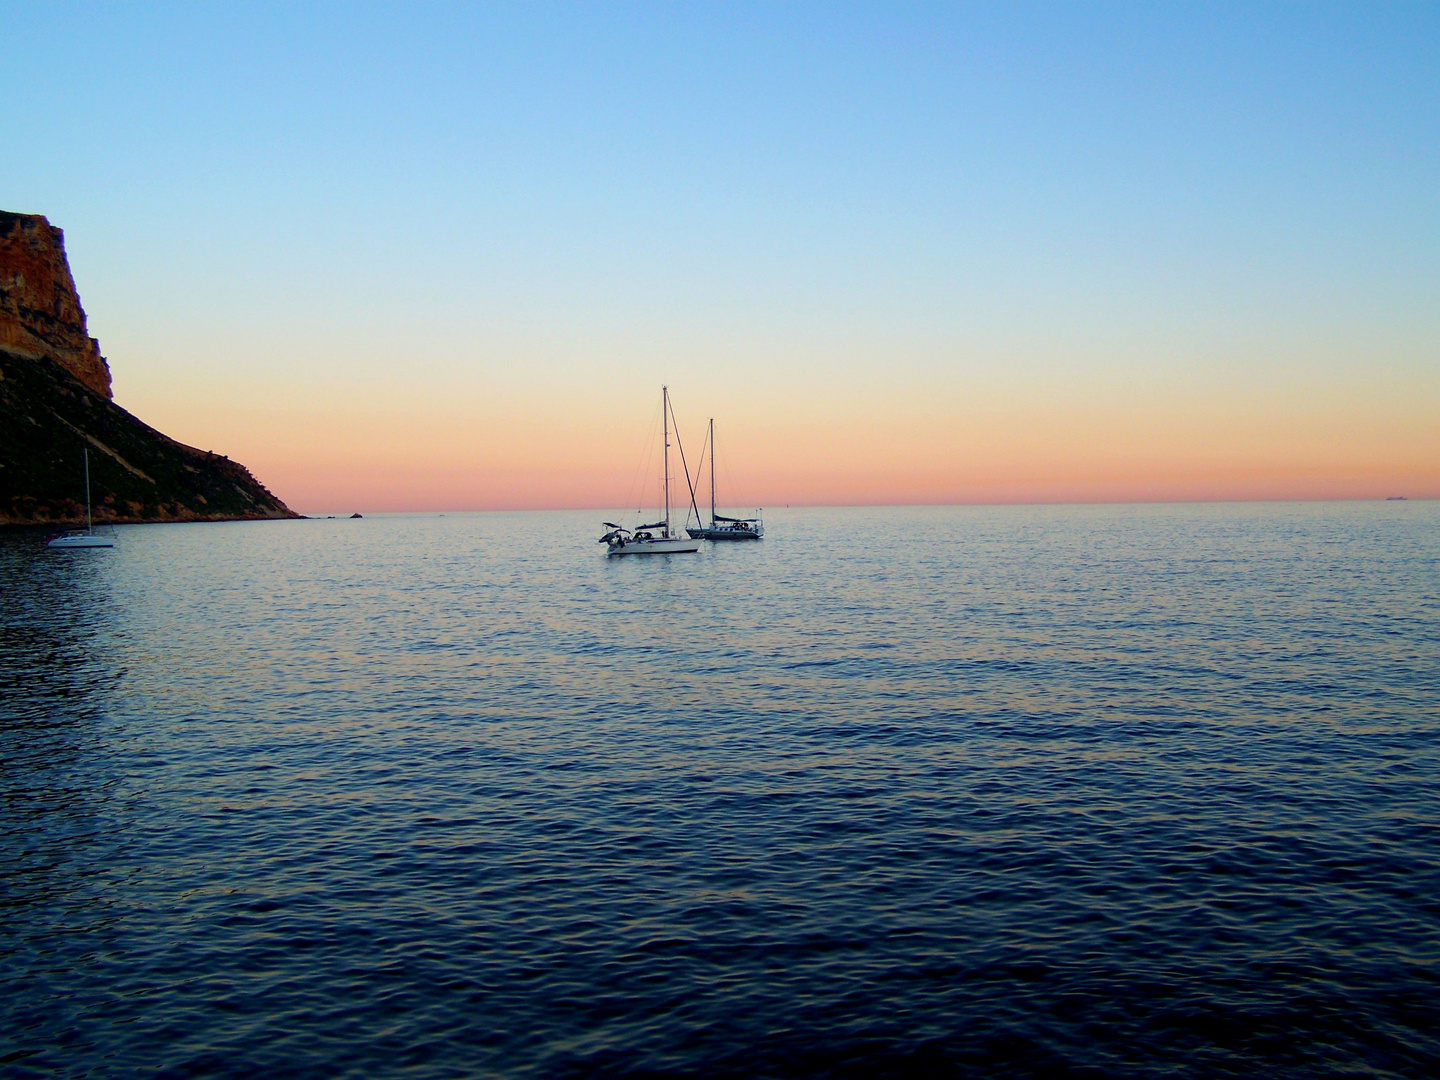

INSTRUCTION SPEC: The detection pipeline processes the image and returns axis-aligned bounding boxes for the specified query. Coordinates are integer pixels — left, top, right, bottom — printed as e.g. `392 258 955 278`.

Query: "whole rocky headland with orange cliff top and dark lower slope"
0 212 298 524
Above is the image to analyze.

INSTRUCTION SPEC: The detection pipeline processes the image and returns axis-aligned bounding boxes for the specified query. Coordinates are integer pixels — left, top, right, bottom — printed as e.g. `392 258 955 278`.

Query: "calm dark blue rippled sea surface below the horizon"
0 503 1440 1077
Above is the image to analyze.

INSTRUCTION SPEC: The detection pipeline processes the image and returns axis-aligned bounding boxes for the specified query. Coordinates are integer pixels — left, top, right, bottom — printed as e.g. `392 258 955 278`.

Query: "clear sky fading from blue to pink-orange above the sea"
0 3 1440 513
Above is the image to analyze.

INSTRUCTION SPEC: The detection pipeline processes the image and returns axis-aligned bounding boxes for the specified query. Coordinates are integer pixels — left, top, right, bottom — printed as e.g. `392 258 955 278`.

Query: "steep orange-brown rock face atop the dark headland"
0 210 112 397
